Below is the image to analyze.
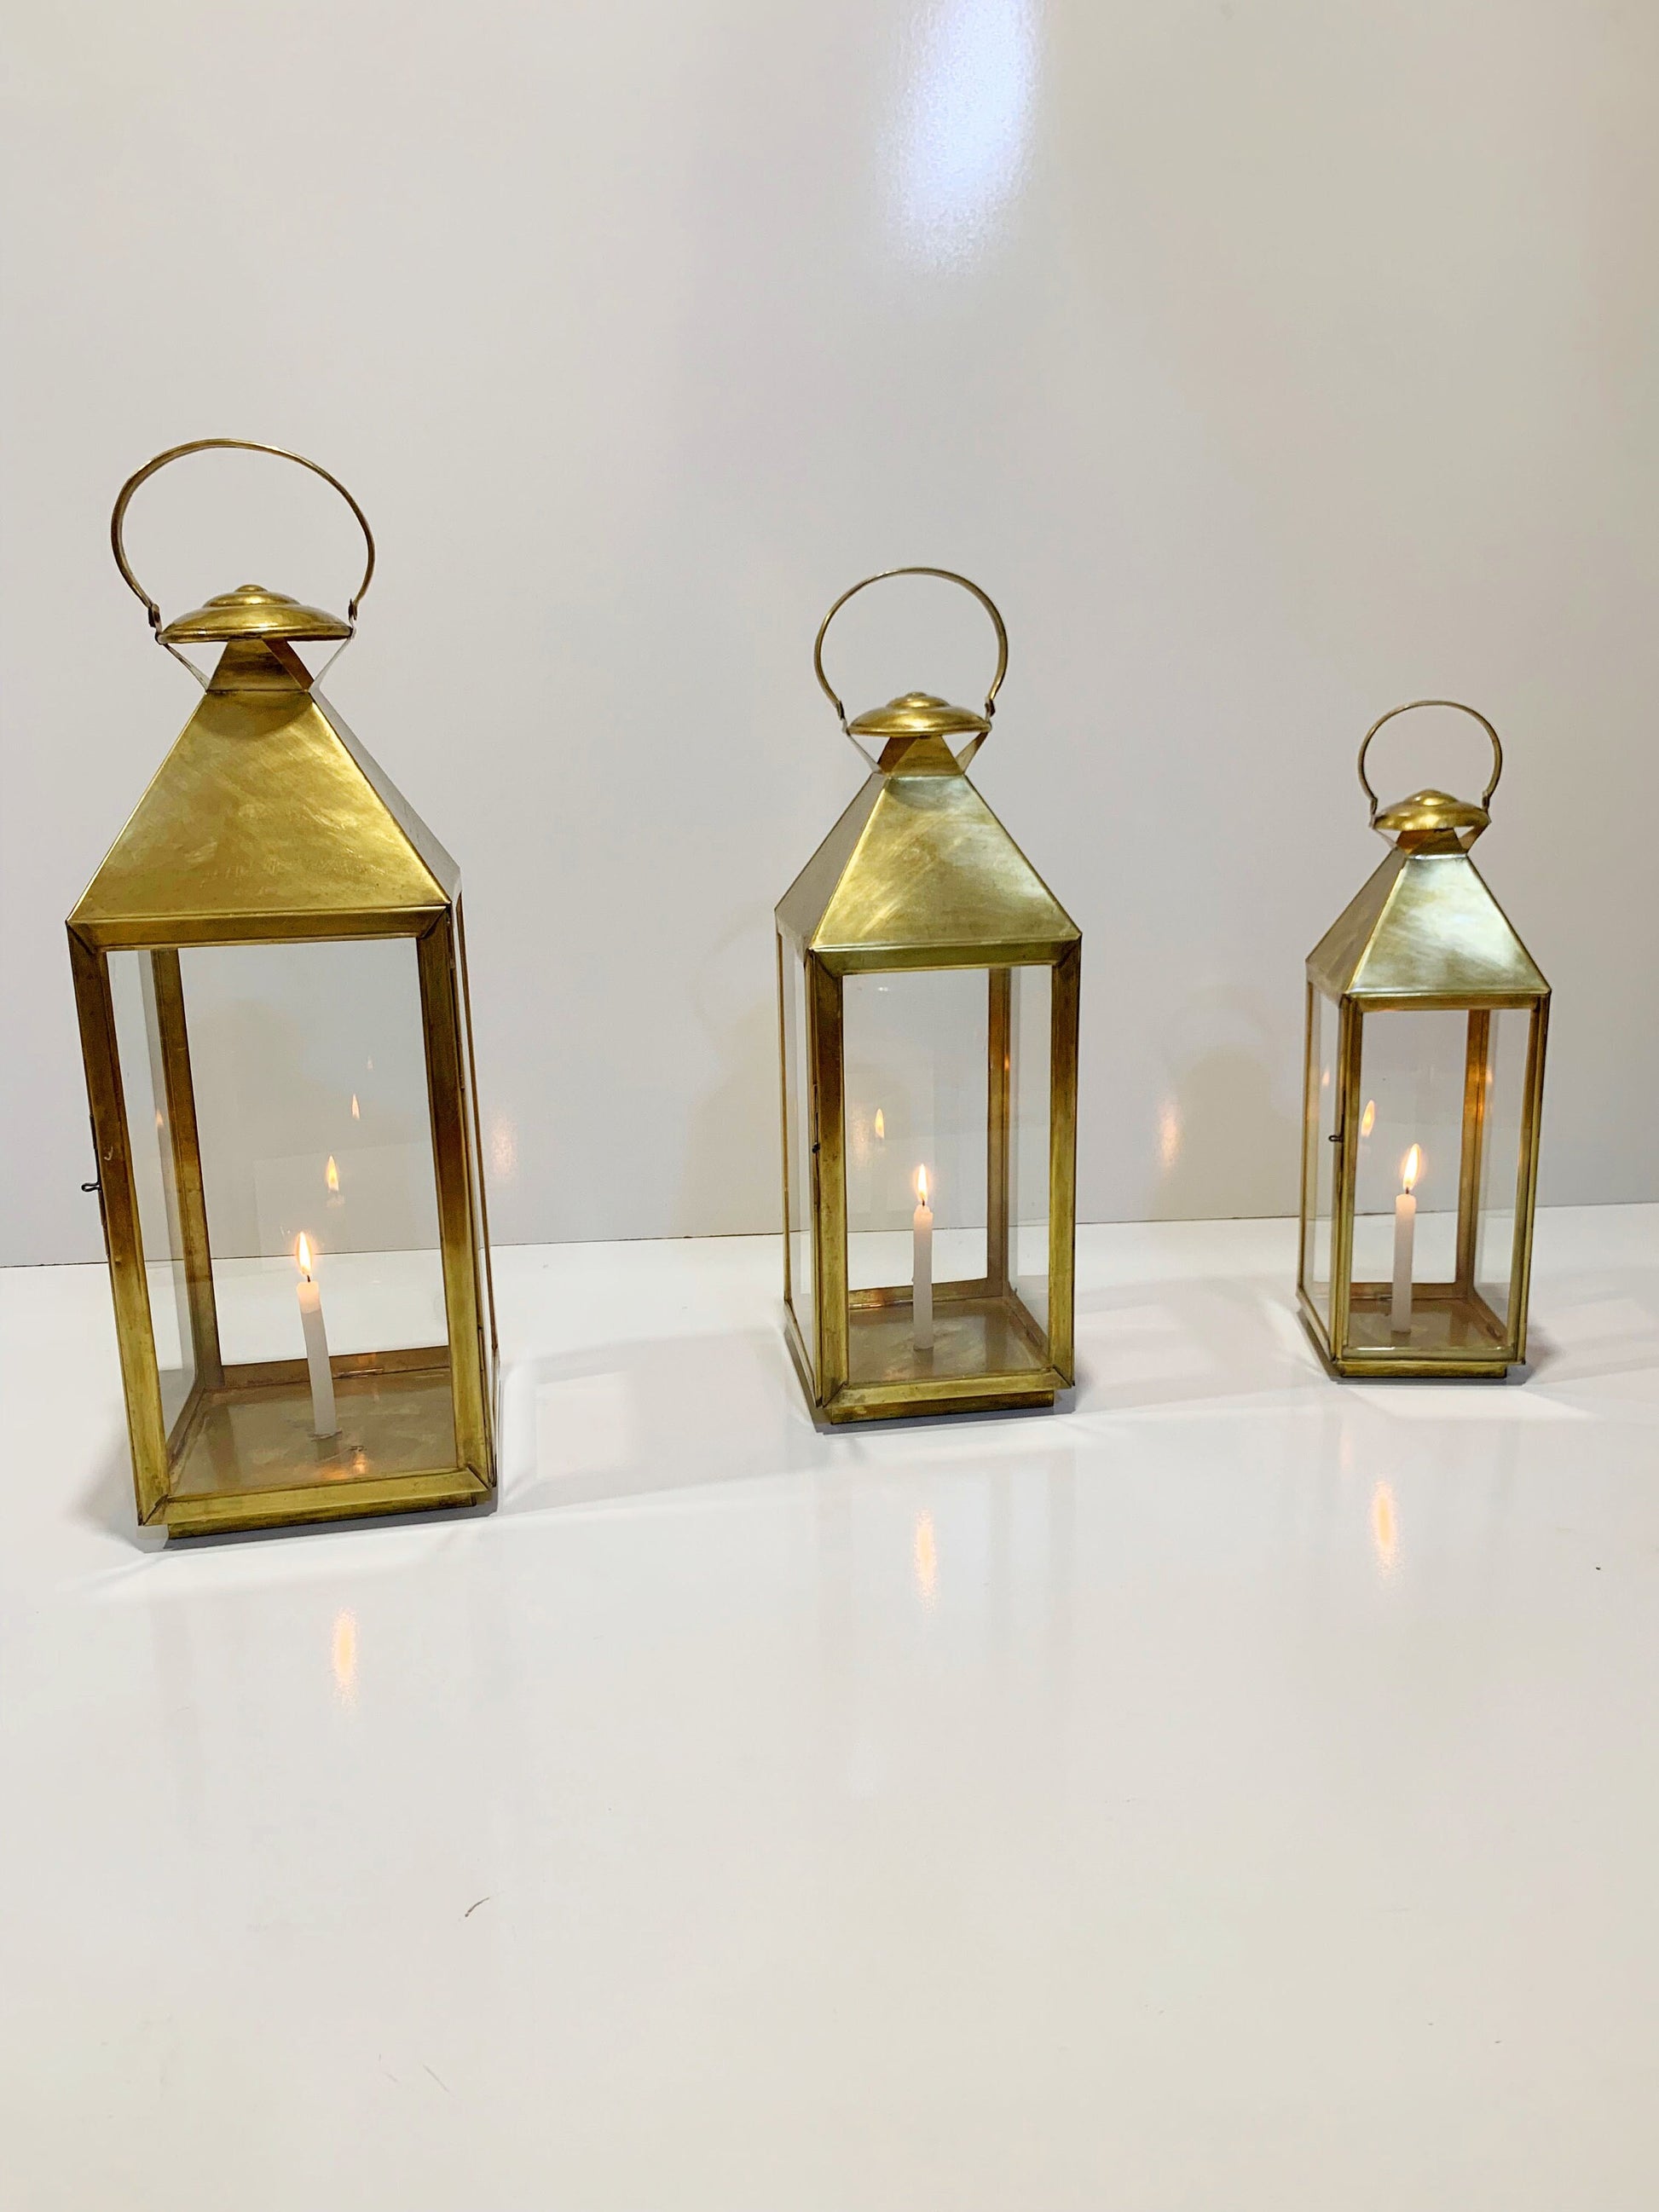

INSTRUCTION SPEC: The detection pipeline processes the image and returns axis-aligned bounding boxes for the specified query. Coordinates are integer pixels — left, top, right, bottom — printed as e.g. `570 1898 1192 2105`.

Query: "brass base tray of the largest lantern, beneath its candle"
153 1354 487 1535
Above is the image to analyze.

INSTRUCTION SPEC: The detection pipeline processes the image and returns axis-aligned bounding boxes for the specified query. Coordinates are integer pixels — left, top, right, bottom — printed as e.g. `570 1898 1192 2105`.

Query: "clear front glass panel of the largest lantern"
127 938 456 1495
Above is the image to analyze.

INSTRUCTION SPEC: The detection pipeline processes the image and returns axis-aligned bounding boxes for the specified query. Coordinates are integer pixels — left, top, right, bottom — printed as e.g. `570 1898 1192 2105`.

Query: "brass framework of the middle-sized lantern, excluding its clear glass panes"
777 569 1082 1423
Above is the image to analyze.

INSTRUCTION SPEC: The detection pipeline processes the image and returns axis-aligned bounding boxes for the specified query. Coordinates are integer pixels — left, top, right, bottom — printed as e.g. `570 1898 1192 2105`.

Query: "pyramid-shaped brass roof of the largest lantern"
68 642 460 947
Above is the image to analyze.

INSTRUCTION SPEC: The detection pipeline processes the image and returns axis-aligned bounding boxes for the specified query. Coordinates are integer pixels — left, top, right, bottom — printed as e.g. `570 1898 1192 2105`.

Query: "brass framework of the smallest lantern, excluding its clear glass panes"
1296 699 1548 1378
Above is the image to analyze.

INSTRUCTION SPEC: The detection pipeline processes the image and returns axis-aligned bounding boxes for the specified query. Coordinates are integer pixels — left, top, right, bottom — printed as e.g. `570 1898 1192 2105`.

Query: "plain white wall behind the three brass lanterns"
0 0 1659 1261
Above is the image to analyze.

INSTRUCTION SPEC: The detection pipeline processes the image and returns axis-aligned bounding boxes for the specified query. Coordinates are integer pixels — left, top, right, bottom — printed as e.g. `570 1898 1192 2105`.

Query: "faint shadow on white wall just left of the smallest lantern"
1148 991 1301 1221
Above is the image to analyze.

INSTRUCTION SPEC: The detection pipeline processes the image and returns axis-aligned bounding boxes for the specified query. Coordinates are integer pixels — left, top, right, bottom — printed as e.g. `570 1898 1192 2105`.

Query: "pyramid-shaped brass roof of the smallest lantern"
1307 834 1548 1004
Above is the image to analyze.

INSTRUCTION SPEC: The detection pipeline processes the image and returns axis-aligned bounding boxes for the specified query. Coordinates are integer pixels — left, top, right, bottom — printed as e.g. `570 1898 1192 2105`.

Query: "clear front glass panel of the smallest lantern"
1347 1008 1513 1360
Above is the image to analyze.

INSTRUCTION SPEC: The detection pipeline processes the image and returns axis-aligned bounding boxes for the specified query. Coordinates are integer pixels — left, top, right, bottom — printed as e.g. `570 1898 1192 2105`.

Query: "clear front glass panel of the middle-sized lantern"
843 969 1046 1383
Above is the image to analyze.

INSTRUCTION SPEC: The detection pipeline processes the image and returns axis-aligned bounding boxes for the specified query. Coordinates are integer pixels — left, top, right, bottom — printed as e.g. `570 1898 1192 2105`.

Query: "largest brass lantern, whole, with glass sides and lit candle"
68 438 495 1535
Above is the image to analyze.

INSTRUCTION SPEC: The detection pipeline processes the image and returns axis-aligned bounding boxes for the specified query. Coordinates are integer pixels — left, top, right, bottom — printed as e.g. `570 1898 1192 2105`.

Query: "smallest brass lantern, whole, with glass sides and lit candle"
1298 699 1548 1376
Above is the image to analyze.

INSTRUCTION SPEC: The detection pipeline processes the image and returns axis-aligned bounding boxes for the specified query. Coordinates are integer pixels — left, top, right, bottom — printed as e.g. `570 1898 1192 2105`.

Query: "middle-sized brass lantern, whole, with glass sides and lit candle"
777 569 1082 1423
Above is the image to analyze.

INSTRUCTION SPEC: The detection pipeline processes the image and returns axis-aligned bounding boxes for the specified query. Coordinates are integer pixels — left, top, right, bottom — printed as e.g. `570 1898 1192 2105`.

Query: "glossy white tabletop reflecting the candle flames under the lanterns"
0 1208 1659 2212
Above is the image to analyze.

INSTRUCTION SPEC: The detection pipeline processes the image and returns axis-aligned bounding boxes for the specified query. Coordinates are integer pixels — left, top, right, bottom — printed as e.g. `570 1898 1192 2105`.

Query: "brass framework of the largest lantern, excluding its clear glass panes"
68 438 498 1533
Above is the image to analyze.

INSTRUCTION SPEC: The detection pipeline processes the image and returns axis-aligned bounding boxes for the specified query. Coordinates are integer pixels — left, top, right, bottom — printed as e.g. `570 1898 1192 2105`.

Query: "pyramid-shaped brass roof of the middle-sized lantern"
777 735 1079 975
